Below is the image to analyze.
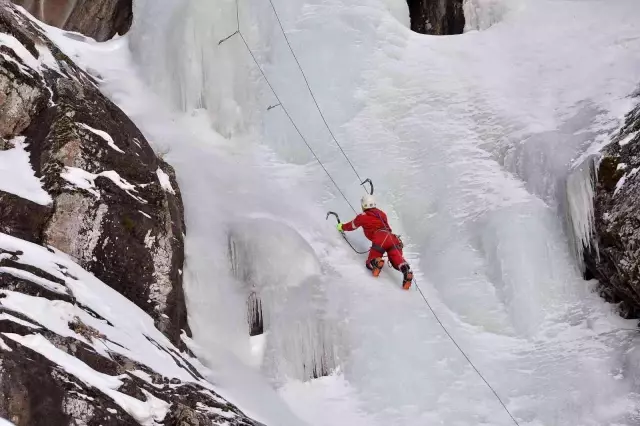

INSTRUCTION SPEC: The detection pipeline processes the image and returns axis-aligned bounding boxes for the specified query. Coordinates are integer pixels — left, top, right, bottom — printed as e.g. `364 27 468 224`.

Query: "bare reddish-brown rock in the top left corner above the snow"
13 0 133 41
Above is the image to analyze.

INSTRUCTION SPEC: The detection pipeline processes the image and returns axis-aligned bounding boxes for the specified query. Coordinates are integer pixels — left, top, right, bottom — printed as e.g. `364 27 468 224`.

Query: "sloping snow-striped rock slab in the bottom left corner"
0 233 258 426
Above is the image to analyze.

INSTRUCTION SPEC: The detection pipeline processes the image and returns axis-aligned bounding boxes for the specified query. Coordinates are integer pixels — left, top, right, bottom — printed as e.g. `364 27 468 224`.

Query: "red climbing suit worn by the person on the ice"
342 208 407 270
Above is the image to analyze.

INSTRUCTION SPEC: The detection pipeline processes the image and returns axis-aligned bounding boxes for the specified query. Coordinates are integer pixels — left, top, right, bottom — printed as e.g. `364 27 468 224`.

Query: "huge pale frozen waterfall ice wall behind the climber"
42 0 640 426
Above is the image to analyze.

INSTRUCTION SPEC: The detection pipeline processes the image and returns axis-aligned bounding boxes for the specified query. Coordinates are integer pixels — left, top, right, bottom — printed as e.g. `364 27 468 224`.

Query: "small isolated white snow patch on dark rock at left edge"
0 136 53 206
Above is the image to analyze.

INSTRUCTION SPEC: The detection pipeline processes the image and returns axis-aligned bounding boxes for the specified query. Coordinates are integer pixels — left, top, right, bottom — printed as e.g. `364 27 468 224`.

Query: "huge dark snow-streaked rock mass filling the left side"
0 4 258 426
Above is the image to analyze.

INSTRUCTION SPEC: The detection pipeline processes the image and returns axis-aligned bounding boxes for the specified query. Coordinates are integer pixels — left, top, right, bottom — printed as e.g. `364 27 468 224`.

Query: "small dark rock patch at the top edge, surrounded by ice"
407 0 465 35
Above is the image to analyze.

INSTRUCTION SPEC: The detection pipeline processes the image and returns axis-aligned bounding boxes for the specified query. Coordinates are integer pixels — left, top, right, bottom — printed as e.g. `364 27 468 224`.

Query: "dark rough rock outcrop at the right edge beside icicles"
584 93 640 318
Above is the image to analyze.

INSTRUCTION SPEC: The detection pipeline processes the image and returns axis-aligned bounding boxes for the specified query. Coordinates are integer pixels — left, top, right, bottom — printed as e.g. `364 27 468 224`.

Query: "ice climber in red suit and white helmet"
338 195 413 290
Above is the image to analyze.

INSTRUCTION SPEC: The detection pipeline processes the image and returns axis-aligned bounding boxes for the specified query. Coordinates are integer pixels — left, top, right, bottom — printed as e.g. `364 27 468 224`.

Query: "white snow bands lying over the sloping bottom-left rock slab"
0 233 240 425
